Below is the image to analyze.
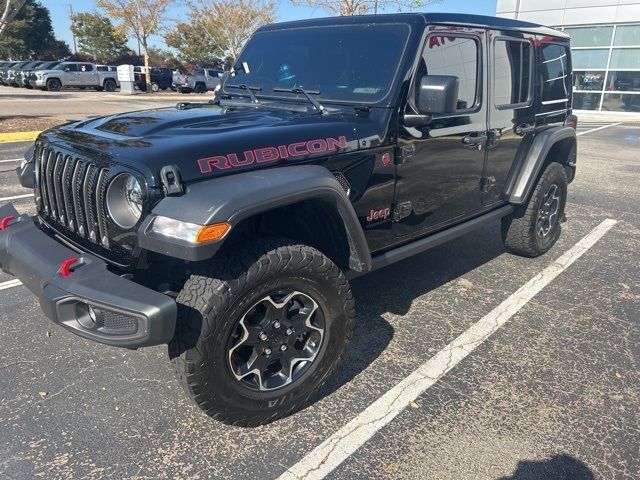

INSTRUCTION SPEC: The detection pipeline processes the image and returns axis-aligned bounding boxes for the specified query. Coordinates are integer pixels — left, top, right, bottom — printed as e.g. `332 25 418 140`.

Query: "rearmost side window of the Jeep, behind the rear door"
540 43 572 104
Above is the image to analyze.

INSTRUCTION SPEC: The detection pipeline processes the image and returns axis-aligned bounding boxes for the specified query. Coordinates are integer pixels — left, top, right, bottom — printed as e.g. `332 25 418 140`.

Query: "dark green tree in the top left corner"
0 0 71 60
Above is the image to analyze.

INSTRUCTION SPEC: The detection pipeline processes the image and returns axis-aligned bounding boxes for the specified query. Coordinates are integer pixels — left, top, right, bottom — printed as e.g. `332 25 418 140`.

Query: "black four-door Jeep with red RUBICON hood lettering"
0 14 577 425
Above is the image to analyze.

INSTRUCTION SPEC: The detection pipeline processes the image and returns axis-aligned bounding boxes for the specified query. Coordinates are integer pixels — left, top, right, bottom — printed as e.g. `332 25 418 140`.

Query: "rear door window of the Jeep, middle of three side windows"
493 39 533 110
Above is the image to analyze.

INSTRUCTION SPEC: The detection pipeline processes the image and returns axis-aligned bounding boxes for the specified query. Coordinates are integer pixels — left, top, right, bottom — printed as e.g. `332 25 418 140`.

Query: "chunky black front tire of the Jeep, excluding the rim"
169 237 354 426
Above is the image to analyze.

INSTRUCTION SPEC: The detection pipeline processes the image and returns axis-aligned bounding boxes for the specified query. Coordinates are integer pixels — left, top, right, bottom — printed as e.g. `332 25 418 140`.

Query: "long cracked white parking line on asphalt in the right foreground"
279 219 616 480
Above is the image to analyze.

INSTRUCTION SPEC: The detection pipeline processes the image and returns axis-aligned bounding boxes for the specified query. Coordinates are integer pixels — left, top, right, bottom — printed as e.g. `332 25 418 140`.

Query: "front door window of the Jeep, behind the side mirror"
416 36 480 111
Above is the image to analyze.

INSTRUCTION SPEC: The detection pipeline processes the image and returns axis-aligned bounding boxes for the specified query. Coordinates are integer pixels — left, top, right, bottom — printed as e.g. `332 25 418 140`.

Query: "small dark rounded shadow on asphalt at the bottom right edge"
498 454 595 480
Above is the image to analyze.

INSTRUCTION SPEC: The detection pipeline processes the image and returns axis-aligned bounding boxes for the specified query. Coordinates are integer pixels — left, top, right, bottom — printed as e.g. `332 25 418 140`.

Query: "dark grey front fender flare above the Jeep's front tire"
138 165 372 273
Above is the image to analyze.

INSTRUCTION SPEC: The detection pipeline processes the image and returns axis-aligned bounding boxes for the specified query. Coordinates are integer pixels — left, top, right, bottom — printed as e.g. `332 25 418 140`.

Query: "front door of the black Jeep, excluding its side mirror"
393 26 487 236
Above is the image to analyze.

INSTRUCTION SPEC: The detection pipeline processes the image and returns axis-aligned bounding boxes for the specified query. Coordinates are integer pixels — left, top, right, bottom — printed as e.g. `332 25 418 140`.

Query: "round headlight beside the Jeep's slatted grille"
107 173 143 229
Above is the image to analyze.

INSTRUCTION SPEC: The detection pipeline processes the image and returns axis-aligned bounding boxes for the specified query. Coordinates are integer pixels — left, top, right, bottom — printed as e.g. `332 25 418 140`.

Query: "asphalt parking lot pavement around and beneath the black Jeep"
0 122 640 480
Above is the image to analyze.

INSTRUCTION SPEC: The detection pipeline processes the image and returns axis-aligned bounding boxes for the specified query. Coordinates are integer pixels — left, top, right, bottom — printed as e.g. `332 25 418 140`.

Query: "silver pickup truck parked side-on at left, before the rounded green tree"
31 62 120 92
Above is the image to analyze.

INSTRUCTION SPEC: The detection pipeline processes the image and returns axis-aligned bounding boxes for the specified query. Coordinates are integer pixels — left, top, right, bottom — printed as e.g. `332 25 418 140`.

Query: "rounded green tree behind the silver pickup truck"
71 12 129 63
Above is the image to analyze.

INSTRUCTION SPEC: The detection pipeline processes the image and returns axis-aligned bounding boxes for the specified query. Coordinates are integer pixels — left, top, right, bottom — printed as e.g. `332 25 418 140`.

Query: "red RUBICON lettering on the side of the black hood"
198 135 347 174
